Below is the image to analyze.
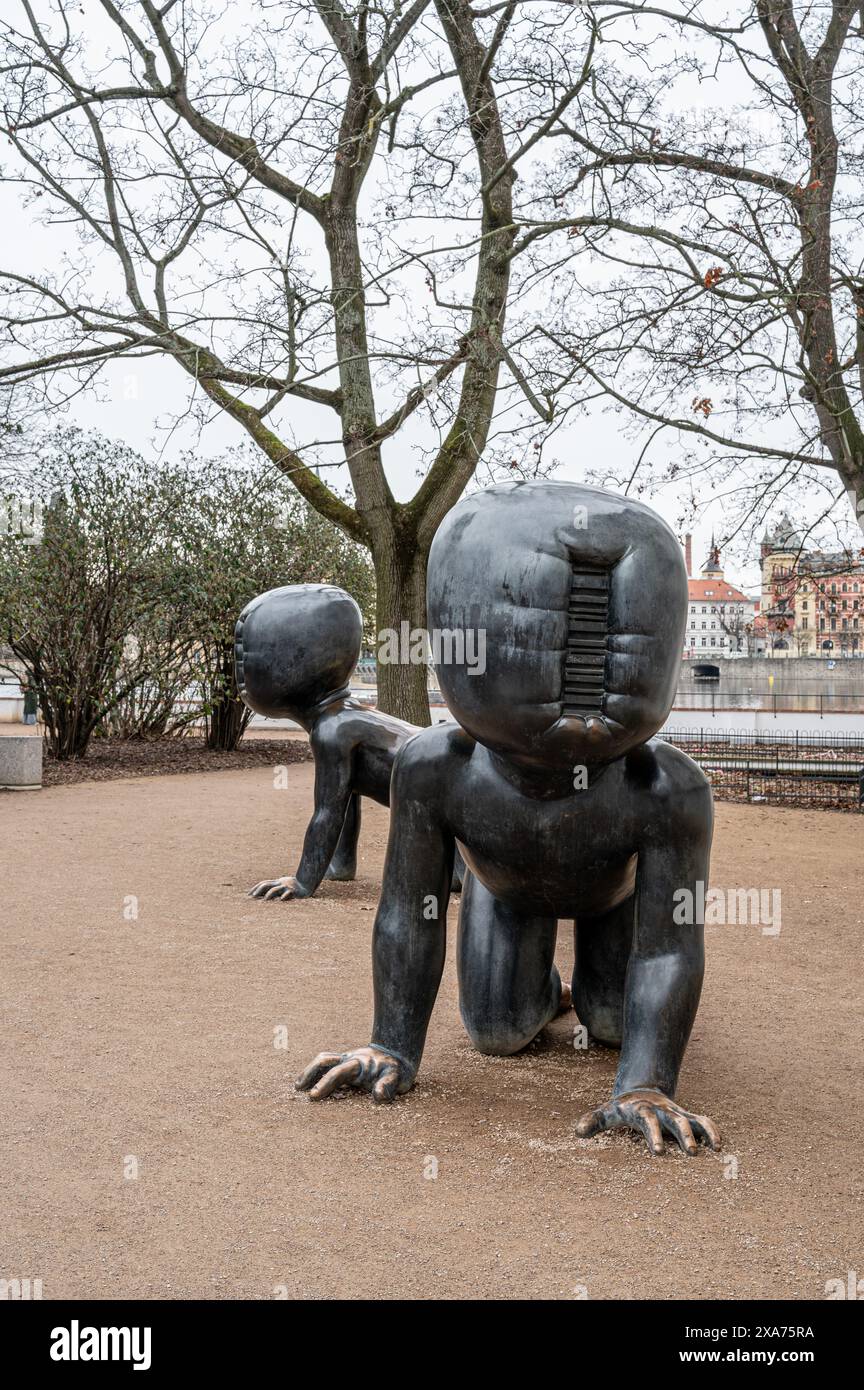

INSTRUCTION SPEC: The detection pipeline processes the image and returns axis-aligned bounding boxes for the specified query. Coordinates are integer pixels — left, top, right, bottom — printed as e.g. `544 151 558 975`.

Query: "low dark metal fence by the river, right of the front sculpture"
658 728 864 810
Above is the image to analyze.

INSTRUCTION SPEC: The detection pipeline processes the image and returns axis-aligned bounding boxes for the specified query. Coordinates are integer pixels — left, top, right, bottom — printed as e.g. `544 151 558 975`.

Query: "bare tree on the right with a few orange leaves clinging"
517 0 864 547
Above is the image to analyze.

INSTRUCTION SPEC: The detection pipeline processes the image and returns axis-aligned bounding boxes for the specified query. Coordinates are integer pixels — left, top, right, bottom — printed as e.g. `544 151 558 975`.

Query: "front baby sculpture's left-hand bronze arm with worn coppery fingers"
297 745 454 1101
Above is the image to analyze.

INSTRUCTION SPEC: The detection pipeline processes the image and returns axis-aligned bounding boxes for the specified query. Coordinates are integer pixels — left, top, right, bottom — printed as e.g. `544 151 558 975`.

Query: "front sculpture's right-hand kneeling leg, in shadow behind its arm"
572 894 636 1047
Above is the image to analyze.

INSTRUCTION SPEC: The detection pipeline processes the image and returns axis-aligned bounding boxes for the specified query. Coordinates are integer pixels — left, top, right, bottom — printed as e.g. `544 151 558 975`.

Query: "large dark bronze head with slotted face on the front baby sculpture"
428 482 688 769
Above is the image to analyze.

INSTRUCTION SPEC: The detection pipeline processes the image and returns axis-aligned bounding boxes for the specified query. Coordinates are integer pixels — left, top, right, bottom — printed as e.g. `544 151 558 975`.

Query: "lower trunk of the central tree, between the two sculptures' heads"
374 538 431 728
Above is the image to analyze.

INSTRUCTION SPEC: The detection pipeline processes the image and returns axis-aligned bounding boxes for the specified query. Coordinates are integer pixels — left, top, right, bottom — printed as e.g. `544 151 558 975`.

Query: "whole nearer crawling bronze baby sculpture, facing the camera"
297 482 720 1154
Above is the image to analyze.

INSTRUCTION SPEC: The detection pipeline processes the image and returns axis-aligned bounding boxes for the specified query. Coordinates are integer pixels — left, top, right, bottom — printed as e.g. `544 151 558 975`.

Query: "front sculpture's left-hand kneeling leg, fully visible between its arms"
458 872 561 1056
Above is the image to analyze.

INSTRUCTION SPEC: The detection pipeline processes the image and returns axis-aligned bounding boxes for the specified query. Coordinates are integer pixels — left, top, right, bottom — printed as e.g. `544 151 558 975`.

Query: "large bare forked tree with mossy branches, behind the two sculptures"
0 0 611 723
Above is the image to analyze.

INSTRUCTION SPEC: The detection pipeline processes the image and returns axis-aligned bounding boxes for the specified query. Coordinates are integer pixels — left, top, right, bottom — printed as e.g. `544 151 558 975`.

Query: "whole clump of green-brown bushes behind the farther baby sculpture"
0 428 374 759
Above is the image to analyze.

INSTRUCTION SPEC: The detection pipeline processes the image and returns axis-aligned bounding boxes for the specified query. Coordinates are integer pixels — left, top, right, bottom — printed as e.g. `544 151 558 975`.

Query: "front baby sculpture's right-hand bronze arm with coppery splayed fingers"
576 788 720 1154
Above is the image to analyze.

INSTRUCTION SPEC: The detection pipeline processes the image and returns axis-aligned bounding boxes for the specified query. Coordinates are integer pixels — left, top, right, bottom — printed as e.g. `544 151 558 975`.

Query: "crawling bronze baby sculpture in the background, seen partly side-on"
235 584 461 901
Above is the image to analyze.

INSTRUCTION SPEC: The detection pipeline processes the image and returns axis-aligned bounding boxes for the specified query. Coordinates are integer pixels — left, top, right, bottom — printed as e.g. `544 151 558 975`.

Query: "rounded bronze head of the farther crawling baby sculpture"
235 584 363 719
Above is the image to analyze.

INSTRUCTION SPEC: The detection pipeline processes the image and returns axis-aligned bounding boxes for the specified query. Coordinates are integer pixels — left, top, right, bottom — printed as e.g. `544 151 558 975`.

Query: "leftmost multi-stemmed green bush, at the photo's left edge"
0 428 187 758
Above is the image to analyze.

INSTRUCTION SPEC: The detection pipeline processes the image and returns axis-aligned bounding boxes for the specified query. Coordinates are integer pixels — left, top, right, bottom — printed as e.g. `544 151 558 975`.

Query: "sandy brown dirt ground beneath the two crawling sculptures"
0 765 864 1300
